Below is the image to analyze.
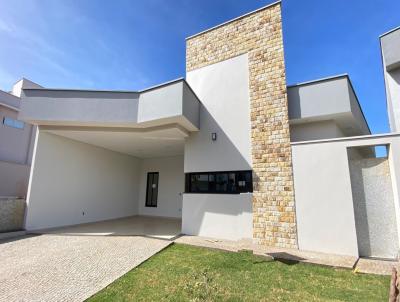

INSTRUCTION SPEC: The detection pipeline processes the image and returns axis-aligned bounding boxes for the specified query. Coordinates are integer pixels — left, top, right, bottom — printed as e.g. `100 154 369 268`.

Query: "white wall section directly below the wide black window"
182 193 253 240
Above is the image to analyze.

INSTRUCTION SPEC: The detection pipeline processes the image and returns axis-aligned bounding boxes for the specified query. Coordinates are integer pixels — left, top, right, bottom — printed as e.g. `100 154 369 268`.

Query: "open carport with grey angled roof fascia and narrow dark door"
19 79 200 234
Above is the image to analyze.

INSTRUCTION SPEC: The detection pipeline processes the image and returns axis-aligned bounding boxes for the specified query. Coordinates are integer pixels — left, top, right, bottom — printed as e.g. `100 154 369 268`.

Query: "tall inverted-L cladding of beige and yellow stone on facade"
186 3 297 248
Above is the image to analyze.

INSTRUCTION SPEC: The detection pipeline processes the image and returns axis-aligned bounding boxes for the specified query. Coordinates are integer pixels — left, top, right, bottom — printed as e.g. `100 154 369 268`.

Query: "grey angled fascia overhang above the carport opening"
19 79 200 131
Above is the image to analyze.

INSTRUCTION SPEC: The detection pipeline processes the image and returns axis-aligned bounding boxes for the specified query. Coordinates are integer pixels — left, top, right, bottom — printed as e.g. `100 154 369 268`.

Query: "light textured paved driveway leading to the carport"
0 234 172 302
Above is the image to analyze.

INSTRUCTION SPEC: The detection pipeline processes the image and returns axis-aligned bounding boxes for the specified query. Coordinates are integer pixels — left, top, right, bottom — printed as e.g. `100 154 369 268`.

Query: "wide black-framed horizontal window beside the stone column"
186 171 253 194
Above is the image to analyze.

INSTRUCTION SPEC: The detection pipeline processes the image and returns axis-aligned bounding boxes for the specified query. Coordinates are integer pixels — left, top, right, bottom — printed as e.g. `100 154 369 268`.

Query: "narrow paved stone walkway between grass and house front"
175 236 399 275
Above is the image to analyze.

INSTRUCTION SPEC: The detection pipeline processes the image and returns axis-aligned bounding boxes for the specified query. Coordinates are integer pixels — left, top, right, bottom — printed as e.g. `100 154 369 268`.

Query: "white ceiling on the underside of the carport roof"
44 128 186 158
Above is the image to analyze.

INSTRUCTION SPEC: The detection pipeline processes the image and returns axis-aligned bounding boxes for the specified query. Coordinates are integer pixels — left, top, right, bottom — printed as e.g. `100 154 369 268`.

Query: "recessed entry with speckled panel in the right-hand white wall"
347 146 398 258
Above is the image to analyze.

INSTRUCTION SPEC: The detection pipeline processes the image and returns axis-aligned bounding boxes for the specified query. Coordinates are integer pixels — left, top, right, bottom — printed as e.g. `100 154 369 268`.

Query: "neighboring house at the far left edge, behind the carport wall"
0 79 40 197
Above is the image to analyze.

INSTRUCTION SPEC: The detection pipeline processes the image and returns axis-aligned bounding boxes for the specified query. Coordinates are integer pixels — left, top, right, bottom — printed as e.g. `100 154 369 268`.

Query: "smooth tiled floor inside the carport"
32 216 181 239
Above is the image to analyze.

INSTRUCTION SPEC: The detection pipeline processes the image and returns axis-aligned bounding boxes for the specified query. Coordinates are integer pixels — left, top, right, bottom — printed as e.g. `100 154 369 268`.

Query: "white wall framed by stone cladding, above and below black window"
182 54 253 240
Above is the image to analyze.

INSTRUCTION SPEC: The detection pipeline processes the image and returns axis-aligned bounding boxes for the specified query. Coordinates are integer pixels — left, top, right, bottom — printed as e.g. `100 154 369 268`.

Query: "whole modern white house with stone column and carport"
19 2 400 258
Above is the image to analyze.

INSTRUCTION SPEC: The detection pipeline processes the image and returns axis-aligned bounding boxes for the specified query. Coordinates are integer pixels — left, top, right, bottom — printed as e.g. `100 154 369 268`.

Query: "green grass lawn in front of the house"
88 244 390 302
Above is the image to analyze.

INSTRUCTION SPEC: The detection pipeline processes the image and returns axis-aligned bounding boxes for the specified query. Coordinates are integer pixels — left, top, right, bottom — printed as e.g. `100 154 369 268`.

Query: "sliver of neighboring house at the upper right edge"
380 27 400 132
